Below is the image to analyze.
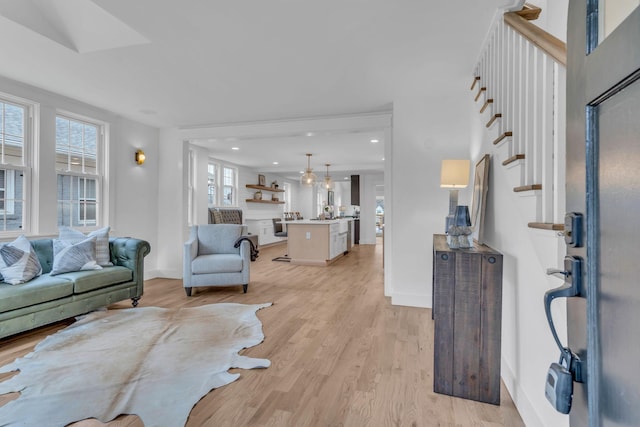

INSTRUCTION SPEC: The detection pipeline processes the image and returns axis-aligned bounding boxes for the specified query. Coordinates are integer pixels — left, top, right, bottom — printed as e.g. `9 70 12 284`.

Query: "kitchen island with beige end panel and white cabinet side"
284 219 351 266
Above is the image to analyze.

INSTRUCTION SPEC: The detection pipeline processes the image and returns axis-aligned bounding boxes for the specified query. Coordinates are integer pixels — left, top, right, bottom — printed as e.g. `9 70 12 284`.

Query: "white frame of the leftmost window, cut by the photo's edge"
0 92 35 237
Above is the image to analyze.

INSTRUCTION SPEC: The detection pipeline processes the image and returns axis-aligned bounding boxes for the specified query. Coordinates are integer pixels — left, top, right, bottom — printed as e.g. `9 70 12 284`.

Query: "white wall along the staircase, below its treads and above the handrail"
467 0 569 427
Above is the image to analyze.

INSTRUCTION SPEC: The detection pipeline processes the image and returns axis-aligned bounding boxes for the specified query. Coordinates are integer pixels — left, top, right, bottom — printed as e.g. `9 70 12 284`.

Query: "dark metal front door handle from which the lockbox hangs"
544 256 583 382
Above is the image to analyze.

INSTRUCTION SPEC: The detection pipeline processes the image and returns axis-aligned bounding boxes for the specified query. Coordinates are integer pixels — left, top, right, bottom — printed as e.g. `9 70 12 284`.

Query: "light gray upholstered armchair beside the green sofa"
182 224 251 296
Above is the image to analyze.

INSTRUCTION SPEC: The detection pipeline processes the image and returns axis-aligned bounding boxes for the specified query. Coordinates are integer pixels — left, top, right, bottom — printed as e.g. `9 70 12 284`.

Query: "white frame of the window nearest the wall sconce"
54 110 109 229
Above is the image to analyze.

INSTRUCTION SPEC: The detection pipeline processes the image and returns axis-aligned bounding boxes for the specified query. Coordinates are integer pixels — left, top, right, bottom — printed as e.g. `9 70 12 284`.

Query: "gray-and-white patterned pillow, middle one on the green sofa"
49 236 102 276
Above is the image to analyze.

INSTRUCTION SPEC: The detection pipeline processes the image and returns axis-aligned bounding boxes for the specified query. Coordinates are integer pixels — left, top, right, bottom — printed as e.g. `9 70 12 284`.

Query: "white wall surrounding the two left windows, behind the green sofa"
0 77 158 278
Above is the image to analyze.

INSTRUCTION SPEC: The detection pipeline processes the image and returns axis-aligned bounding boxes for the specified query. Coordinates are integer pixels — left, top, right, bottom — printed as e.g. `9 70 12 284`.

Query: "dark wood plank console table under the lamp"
433 234 502 405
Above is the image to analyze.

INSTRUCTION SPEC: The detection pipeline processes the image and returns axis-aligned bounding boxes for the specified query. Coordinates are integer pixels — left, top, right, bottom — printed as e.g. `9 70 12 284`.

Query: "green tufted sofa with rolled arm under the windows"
0 237 151 338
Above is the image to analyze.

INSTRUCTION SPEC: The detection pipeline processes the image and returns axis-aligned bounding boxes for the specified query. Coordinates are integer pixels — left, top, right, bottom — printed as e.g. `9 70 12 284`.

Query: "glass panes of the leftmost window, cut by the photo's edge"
0 95 33 232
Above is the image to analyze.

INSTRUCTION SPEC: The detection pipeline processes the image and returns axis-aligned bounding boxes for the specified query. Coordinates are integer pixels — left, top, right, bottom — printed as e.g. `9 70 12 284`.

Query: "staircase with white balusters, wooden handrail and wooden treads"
471 4 566 232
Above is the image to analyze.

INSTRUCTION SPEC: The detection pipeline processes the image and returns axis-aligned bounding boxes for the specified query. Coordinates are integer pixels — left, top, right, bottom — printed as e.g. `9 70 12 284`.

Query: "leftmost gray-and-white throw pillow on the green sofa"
0 235 42 285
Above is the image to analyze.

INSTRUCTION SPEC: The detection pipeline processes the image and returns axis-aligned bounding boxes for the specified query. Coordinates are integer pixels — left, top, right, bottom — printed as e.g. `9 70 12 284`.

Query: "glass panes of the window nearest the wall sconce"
55 116 104 227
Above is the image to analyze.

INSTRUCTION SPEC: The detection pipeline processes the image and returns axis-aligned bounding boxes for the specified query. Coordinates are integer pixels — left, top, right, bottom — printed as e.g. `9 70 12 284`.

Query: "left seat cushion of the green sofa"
0 274 73 312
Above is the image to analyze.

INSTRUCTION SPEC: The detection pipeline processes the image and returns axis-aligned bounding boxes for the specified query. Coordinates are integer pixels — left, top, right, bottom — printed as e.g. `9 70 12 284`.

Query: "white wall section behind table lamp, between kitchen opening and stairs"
388 93 471 307
